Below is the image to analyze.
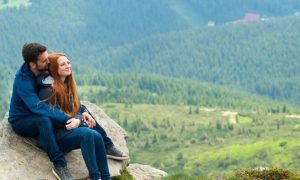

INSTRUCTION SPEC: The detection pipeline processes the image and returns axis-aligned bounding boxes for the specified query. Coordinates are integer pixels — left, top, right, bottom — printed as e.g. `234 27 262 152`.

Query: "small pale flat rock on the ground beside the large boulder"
127 164 168 180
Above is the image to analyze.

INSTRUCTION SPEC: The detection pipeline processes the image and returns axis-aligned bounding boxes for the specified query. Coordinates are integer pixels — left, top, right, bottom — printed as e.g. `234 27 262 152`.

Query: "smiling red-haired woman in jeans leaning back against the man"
38 53 114 180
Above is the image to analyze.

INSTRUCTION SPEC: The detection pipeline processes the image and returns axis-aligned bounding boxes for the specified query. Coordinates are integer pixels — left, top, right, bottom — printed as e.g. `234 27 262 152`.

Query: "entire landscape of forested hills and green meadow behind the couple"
0 0 300 177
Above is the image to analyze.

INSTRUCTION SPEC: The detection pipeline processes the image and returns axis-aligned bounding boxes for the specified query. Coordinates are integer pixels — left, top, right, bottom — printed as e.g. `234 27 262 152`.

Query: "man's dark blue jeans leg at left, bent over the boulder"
11 115 67 167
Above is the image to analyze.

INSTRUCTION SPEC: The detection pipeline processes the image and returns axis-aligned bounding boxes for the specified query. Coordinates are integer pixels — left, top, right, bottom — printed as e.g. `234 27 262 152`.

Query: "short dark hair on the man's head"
22 43 47 64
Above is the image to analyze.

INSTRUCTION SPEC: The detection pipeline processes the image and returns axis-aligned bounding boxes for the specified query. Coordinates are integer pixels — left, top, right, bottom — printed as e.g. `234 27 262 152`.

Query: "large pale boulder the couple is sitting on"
0 102 129 179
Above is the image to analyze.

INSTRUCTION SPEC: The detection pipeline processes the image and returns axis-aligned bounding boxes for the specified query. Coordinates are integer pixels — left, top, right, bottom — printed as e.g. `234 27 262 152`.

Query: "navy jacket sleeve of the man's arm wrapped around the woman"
17 76 71 123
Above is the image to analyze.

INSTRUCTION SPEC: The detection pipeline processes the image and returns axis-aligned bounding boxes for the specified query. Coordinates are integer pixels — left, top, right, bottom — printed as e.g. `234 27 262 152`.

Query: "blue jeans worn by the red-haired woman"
55 124 111 180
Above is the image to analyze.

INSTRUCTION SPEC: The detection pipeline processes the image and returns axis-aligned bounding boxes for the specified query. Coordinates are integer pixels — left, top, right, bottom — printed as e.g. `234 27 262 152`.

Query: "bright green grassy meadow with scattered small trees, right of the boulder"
100 103 300 178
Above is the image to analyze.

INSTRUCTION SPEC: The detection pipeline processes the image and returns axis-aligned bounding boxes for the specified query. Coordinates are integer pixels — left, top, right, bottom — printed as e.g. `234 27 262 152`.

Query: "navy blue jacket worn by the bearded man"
8 63 71 123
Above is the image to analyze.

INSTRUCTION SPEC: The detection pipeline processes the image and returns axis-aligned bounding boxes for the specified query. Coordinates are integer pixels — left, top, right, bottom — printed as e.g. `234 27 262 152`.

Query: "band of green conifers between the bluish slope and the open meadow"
76 73 296 114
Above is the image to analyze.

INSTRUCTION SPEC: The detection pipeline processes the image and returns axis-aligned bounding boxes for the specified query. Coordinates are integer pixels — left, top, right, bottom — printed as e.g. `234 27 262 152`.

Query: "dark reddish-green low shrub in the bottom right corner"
232 168 300 180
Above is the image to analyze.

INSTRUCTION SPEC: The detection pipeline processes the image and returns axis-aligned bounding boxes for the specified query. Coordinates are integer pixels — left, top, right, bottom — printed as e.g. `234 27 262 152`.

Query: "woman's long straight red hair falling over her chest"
49 53 80 117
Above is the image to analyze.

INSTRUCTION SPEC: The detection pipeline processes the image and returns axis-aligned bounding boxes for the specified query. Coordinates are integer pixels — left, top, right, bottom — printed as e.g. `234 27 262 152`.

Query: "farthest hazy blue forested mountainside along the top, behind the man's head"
0 0 300 67
